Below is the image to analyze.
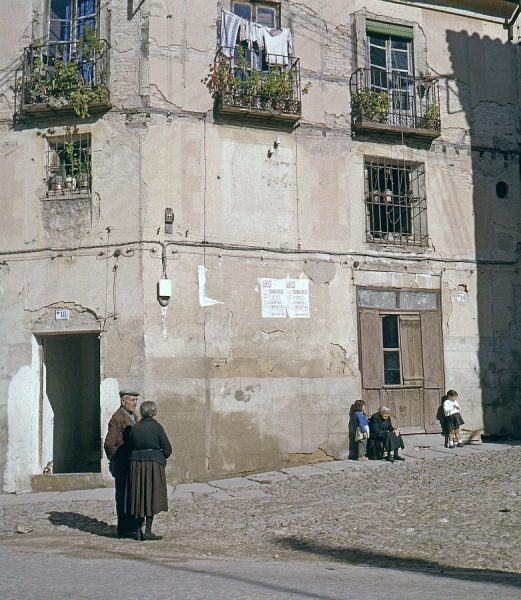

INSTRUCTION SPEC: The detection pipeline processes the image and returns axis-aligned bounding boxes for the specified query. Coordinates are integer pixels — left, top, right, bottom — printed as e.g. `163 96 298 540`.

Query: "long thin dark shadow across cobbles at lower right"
273 536 521 587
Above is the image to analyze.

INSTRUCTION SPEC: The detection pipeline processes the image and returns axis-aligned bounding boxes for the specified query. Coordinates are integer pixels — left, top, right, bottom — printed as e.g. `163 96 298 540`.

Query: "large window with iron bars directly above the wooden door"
365 158 428 246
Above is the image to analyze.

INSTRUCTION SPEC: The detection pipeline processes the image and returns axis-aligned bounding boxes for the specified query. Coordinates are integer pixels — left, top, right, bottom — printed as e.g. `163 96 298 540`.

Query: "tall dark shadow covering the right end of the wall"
442 31 521 438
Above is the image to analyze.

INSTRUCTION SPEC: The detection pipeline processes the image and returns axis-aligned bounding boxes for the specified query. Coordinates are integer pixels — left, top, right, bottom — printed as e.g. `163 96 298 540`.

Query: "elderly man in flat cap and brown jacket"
104 391 139 538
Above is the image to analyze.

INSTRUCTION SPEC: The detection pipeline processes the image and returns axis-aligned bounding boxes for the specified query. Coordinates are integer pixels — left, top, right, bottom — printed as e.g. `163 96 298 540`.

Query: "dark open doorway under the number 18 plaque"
42 334 101 473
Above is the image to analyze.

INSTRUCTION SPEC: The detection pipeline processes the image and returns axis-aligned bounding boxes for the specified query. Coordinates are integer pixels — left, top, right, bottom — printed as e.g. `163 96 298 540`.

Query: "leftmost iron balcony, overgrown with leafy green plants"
15 36 110 119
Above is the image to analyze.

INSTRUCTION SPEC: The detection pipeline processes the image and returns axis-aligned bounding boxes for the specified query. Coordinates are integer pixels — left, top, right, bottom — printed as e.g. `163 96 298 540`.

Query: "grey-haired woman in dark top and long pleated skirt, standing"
126 400 172 540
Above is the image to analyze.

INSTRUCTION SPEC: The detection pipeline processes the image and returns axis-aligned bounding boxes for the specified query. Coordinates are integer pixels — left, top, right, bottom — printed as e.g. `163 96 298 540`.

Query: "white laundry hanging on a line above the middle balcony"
221 10 293 66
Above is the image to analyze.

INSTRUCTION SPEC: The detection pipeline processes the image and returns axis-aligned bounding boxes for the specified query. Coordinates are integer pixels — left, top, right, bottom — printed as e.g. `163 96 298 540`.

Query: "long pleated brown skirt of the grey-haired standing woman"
125 460 168 517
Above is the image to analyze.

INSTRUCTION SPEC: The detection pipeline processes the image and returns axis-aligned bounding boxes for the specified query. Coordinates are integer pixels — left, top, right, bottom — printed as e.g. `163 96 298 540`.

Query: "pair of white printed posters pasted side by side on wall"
260 278 309 319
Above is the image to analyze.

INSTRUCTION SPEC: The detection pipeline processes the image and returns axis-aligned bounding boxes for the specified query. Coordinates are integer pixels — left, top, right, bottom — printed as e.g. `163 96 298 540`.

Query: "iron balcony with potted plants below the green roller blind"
350 69 441 139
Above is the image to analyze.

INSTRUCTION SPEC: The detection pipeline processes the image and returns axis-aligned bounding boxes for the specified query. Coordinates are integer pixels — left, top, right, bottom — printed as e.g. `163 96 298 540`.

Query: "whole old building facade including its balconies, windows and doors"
0 0 521 492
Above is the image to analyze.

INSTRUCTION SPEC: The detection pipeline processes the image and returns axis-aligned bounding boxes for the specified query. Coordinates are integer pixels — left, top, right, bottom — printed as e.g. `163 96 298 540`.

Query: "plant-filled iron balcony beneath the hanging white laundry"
205 47 302 124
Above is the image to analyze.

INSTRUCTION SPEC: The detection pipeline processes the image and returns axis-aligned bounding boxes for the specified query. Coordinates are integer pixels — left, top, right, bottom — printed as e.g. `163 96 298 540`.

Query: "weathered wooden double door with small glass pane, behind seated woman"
358 290 443 433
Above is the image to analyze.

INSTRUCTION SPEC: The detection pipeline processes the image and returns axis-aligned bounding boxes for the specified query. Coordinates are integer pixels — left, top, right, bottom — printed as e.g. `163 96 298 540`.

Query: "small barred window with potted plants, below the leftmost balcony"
45 134 92 196
